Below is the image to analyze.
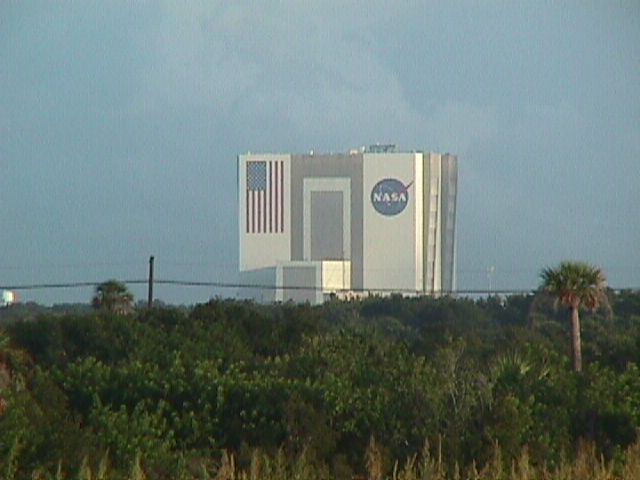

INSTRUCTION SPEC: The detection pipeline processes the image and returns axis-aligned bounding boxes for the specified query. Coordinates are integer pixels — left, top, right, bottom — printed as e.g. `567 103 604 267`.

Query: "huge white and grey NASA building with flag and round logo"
238 145 458 303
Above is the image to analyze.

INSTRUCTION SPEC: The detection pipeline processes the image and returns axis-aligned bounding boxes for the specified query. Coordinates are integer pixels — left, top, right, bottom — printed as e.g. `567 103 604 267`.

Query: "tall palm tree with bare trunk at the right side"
541 262 607 372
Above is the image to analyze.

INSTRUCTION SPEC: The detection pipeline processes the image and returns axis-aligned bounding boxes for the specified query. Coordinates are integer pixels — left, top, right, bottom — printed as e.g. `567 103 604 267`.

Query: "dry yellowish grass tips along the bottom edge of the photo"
0 439 640 480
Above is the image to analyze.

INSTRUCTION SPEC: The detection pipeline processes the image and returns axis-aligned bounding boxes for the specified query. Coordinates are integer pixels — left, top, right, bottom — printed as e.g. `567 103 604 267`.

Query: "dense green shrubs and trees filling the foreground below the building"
0 292 640 479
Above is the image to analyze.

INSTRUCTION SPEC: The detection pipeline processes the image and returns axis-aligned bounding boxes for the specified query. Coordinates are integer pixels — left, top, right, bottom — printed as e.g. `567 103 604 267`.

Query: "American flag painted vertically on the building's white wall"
246 160 284 233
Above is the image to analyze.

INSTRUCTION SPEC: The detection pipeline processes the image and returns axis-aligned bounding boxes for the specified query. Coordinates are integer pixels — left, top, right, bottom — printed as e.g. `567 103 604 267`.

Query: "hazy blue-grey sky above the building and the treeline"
0 0 640 304
